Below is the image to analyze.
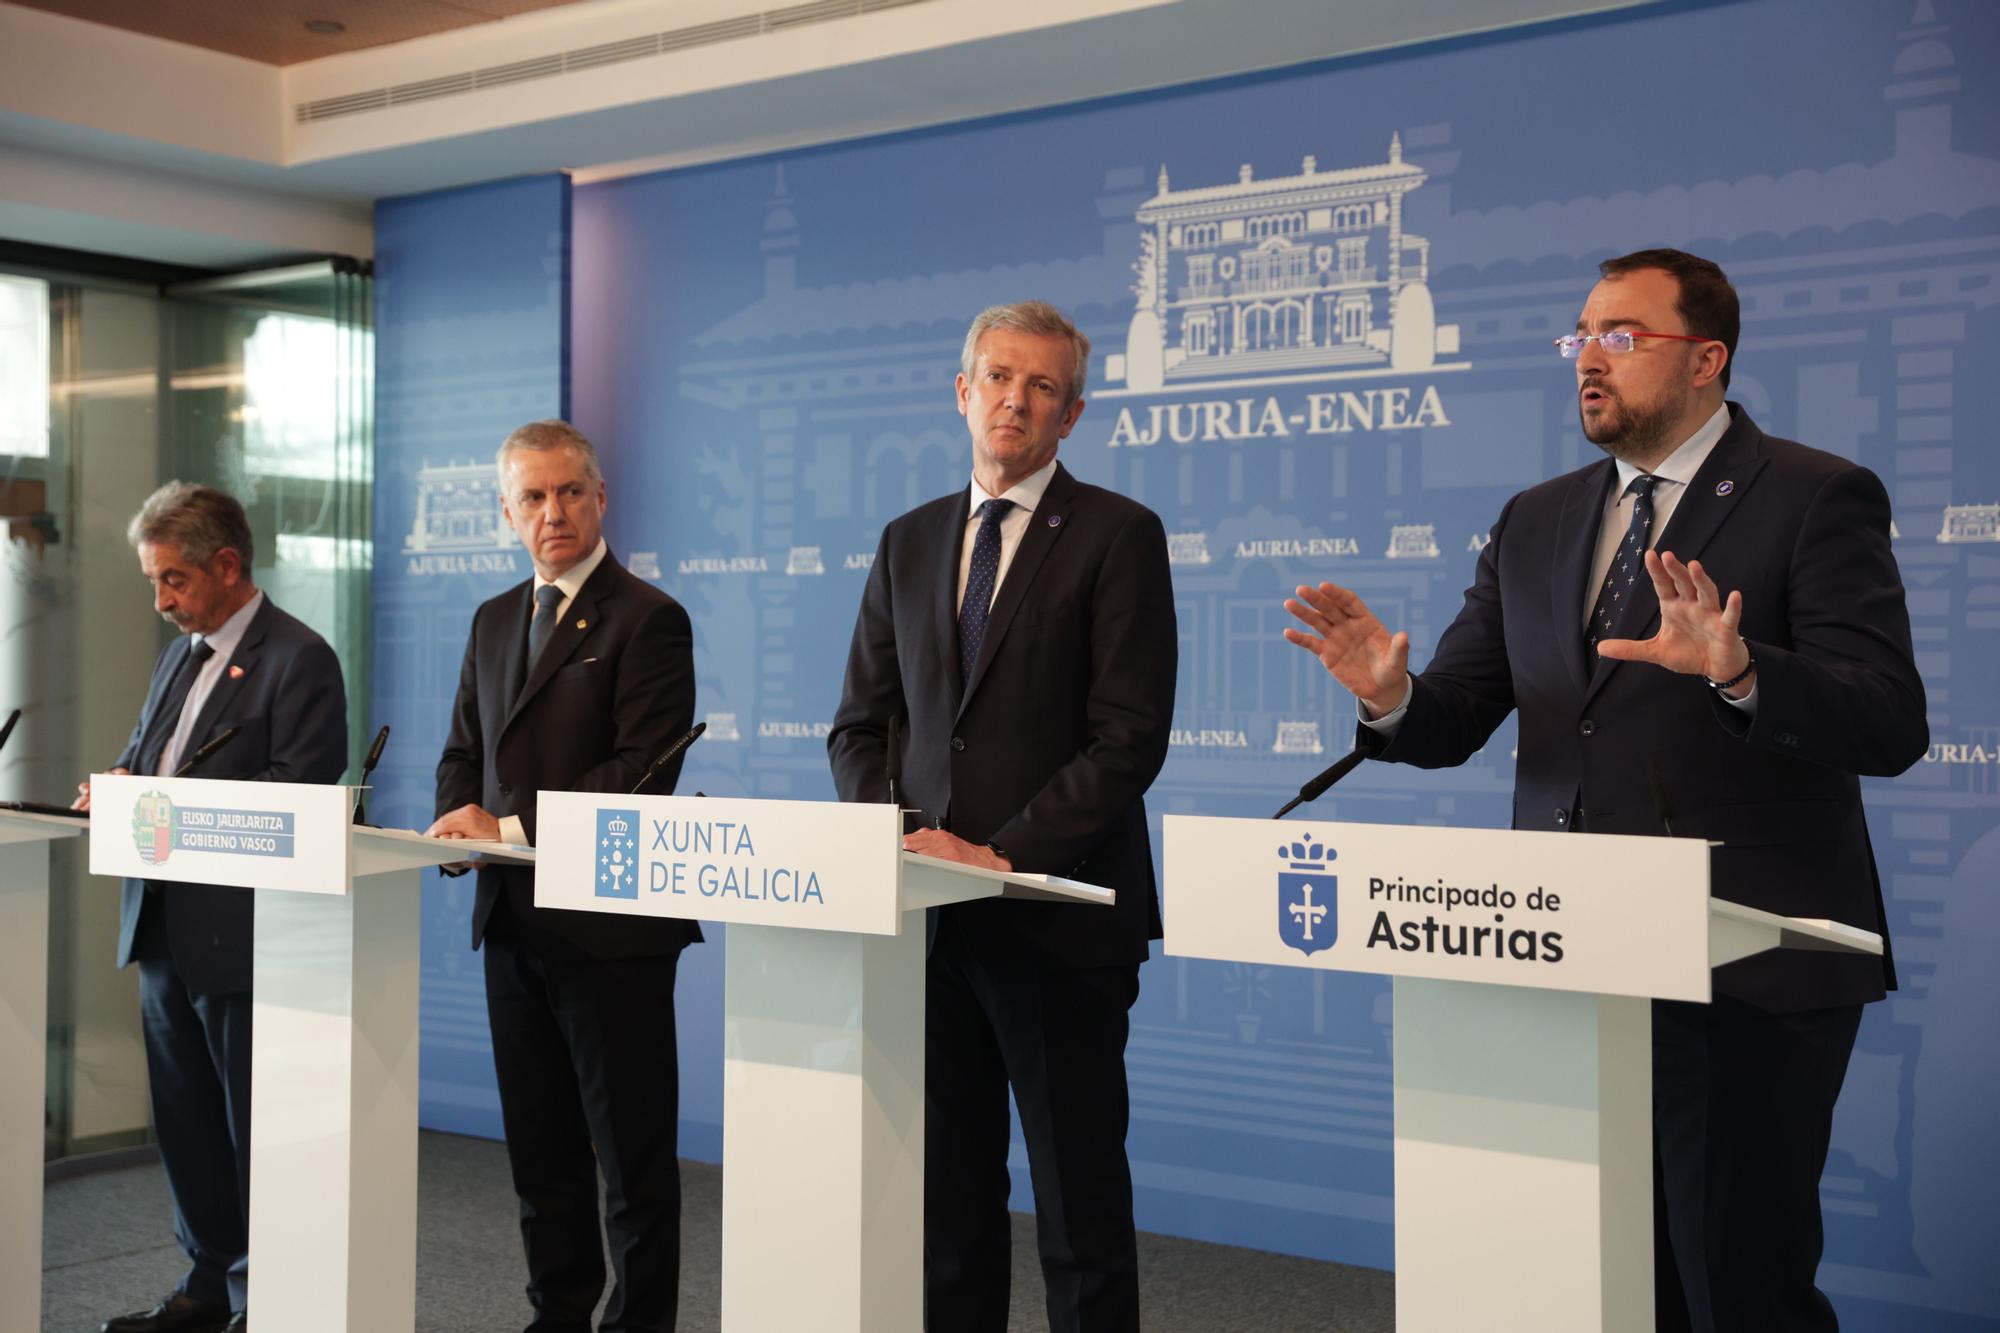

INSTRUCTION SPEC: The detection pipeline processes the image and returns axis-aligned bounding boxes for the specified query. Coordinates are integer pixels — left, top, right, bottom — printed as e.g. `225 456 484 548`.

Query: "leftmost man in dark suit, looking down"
76 482 348 1333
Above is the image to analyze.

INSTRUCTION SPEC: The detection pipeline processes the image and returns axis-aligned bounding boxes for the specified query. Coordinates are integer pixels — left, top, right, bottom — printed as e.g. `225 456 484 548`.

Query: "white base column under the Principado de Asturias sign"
1394 977 1654 1333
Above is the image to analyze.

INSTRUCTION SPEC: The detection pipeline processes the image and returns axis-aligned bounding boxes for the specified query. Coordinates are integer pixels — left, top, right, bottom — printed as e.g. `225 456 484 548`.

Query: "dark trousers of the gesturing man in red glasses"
1652 999 1862 1333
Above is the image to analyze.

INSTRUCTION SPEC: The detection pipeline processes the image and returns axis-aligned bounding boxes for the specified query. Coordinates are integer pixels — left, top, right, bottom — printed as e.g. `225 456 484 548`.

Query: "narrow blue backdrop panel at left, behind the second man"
370 176 570 1139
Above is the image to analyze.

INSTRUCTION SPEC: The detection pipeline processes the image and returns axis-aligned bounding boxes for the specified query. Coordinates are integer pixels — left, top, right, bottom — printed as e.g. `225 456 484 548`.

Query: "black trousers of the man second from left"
482 903 680 1333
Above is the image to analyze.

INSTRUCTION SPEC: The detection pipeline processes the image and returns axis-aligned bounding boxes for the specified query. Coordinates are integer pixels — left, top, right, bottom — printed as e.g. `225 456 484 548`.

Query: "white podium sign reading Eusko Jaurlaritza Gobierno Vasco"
90 773 354 893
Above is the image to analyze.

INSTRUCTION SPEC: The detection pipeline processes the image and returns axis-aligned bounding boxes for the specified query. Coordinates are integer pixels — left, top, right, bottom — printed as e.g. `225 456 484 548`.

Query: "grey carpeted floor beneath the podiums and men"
42 1133 1396 1333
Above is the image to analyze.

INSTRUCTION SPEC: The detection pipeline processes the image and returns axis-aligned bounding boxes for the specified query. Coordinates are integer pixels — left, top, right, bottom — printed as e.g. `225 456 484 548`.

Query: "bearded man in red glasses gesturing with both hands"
1286 250 1928 1329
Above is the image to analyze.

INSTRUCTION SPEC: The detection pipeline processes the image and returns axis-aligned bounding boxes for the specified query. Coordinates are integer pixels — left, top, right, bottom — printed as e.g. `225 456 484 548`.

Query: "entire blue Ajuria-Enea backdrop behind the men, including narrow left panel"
376 0 2000 1329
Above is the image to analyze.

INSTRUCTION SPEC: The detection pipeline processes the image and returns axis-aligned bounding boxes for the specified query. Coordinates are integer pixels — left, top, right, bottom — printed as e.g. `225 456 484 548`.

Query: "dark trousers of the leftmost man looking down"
132 889 250 1309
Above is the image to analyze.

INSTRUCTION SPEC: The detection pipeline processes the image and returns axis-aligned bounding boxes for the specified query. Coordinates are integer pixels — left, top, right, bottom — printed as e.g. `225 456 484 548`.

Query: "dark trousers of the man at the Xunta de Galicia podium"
924 911 1138 1333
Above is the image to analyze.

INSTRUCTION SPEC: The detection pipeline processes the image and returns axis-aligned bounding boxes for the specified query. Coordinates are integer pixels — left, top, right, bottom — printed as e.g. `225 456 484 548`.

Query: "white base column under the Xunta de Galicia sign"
722 913 924 1333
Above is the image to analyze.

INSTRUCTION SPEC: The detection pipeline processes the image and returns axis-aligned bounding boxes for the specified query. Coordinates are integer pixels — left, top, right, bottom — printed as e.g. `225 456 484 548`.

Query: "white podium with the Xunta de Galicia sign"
534 791 1112 1333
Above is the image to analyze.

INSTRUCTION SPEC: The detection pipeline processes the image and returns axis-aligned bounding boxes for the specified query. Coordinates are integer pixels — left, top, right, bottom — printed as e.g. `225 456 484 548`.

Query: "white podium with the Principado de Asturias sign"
1164 815 1882 1333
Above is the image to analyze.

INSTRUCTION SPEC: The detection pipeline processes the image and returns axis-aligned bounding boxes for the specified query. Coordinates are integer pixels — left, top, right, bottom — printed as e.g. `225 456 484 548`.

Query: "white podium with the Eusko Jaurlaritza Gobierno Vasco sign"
87 773 532 1333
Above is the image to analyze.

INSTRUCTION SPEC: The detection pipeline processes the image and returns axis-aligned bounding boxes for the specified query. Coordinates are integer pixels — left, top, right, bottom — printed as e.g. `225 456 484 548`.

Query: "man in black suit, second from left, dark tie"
430 420 702 1333
